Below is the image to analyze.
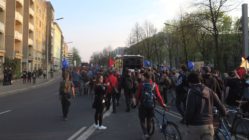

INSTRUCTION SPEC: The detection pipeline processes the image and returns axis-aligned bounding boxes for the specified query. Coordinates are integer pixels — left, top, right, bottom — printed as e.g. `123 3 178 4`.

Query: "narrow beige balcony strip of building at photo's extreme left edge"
0 0 6 79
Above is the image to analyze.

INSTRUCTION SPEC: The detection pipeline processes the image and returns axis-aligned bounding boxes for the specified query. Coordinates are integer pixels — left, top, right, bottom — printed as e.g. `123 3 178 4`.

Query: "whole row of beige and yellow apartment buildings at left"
0 0 60 78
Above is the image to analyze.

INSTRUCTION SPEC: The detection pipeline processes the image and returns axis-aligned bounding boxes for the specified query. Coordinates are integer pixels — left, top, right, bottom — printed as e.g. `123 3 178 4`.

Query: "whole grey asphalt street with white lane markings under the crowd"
0 79 186 140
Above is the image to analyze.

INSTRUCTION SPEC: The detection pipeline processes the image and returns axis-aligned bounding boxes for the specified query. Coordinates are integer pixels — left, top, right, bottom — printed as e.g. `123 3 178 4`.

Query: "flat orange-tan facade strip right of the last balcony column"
32 0 46 69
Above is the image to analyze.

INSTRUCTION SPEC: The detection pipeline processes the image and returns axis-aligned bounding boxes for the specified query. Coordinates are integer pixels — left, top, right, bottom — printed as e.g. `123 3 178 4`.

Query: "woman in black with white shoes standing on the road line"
93 75 107 130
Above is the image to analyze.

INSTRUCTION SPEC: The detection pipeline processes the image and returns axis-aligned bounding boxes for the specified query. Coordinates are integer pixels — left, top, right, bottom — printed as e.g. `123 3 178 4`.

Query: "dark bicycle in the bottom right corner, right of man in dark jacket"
214 108 249 140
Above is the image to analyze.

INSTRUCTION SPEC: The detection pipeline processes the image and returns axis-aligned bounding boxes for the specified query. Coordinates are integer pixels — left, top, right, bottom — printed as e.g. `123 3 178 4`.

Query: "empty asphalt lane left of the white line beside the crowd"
0 80 93 140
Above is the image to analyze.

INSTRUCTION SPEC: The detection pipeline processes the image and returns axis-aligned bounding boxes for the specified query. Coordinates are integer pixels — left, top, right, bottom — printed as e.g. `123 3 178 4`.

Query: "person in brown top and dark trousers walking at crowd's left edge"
59 72 75 121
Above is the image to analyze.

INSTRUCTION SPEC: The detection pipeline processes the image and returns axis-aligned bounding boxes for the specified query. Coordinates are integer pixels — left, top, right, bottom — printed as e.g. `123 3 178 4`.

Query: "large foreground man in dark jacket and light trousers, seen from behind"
184 72 226 140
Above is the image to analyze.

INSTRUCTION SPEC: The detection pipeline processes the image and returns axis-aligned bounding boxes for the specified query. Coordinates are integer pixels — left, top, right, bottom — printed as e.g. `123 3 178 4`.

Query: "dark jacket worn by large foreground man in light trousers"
184 84 226 125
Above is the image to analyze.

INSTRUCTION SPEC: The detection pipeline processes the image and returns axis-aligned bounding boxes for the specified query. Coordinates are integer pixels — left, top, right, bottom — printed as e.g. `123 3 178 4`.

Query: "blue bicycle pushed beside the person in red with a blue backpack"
148 108 182 140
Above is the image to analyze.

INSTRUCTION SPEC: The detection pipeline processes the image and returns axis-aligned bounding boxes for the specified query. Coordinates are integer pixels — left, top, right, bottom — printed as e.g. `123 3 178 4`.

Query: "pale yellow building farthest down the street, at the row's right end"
51 22 63 70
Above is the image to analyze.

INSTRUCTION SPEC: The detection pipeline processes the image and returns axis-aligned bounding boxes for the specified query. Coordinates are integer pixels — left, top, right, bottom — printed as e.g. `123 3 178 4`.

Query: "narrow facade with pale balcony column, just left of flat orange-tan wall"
22 0 34 71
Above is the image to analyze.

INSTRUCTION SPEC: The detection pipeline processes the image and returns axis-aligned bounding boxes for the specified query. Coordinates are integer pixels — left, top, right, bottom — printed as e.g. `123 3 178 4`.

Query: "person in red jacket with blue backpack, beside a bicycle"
136 72 166 139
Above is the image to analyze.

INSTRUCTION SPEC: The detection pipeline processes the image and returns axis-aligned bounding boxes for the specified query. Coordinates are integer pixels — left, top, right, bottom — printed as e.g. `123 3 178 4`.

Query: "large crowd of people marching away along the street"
60 65 249 139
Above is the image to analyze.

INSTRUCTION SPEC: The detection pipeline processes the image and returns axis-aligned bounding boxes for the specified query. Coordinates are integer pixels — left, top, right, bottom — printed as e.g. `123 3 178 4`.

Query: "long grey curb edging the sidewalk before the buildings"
0 76 60 97
